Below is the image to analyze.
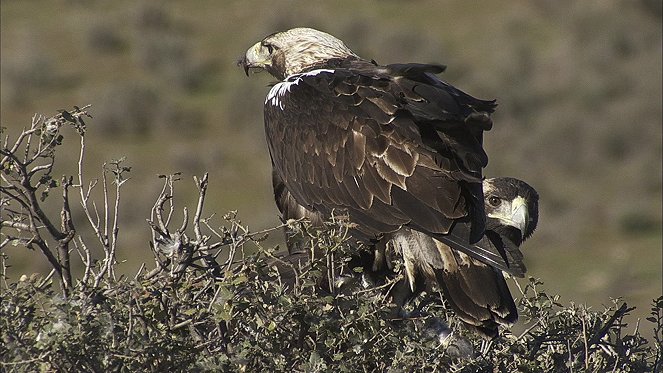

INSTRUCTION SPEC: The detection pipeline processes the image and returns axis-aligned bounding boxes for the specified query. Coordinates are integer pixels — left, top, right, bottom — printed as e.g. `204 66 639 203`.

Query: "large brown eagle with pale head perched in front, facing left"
239 28 526 337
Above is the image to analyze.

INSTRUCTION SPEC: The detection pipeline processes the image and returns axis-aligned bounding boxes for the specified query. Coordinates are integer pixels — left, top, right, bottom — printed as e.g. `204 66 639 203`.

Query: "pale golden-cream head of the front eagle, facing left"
238 27 357 80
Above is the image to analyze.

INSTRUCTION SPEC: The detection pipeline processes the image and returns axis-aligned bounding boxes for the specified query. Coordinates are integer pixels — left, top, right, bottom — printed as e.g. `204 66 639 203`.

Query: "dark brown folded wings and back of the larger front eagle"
265 64 519 272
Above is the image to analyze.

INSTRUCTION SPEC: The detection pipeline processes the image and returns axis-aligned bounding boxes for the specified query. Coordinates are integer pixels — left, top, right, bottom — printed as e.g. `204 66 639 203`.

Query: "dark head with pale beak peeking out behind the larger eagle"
483 177 539 241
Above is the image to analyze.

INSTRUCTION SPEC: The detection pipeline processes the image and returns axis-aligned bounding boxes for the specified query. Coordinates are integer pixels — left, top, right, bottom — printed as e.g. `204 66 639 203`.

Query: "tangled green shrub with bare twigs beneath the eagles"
0 107 663 372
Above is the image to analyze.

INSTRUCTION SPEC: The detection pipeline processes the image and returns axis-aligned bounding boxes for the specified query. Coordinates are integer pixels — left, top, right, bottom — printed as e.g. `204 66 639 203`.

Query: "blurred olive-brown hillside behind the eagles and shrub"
0 0 663 328
